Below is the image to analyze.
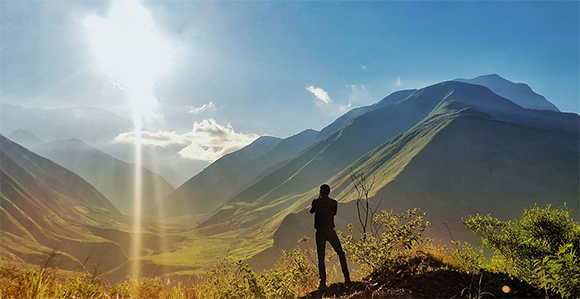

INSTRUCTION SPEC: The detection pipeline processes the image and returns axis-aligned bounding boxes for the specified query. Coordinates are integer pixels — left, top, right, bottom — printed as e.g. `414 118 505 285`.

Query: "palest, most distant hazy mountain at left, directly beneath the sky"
0 103 133 144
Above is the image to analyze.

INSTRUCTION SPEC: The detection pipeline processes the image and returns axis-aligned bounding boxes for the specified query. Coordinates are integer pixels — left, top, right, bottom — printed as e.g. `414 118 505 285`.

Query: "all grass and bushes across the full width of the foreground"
0 205 580 299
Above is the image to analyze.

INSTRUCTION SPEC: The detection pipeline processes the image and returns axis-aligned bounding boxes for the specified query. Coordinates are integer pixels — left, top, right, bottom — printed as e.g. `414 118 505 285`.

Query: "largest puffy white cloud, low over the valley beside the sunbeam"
115 118 259 162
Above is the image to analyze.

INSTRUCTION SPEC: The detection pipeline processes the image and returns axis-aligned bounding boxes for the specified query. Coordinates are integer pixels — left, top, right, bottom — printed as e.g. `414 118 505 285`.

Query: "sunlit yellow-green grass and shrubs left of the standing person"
0 248 318 299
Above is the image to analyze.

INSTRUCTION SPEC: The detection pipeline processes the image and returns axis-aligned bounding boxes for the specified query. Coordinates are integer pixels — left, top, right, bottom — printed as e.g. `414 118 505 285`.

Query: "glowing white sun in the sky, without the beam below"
84 0 169 117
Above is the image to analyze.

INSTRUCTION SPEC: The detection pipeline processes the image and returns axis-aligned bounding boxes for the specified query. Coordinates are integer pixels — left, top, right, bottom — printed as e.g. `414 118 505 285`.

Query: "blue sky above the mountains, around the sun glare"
0 1 580 162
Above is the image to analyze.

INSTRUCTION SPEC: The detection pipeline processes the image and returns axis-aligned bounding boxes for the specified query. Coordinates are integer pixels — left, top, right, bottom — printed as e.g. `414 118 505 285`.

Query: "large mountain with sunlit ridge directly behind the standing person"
189 81 580 268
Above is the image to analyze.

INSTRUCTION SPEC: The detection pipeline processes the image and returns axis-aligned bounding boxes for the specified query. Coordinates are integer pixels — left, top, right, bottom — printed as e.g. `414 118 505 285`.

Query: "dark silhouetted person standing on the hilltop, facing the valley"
310 184 350 289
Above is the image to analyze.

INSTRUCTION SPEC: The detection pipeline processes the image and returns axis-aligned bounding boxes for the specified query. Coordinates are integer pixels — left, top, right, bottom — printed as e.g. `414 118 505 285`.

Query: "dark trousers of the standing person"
316 228 350 285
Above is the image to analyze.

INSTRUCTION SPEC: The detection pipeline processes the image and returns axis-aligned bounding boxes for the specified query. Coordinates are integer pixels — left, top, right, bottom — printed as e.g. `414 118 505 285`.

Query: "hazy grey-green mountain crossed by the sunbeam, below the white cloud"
33 139 175 214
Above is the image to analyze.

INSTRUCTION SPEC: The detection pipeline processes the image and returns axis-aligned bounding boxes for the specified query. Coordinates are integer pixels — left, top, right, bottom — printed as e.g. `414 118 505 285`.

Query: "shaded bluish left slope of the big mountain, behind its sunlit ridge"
220 82 482 209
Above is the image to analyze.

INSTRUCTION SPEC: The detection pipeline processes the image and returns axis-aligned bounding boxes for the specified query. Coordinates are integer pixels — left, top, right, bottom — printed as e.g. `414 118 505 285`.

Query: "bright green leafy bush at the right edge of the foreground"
463 205 580 297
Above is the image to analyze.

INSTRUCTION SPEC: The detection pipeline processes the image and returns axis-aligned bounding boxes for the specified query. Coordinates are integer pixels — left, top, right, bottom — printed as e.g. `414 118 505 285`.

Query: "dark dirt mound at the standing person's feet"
303 269 552 298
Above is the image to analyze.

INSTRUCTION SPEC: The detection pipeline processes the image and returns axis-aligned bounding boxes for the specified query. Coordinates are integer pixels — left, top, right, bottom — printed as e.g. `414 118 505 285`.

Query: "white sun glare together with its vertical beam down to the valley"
84 0 169 284
